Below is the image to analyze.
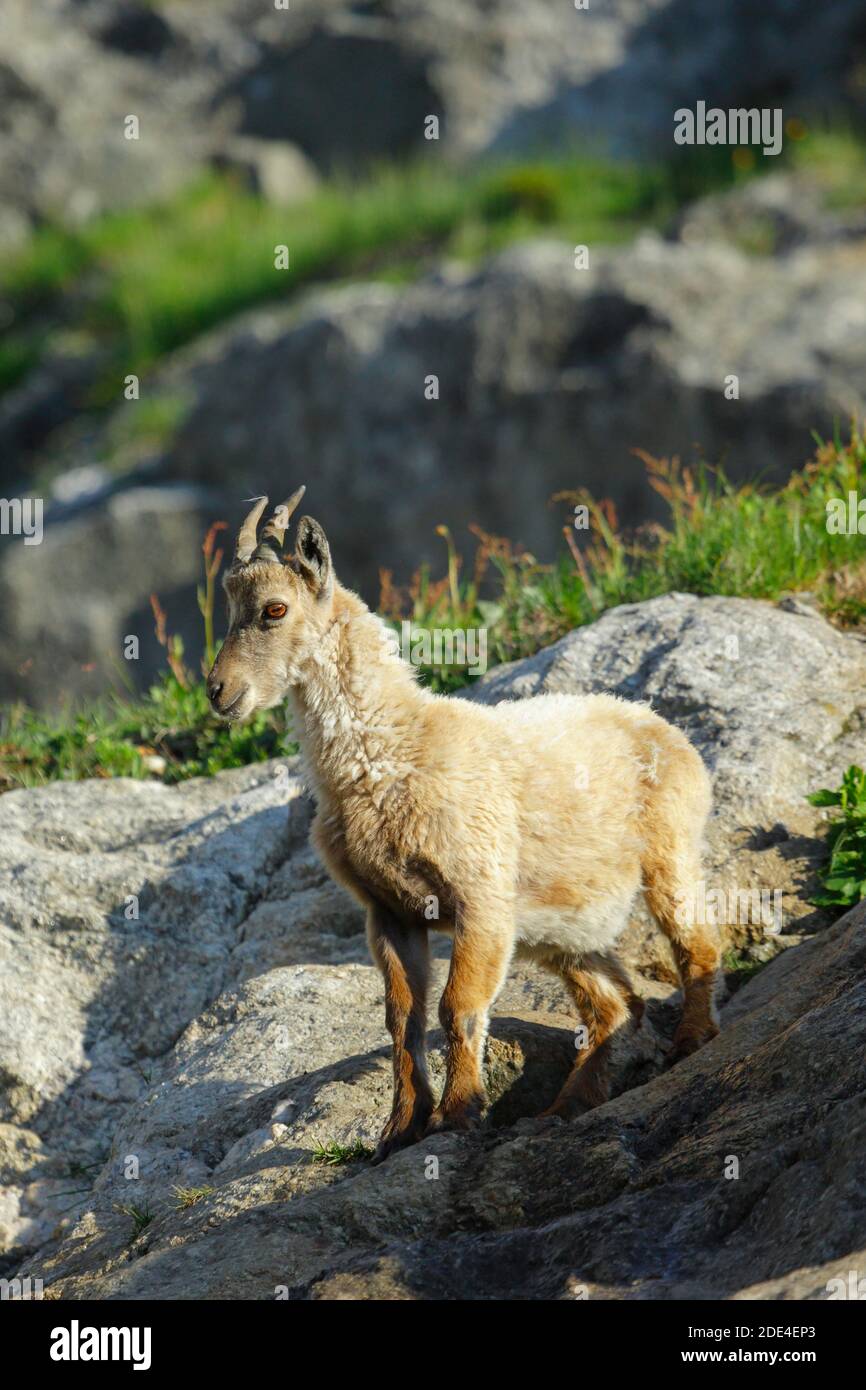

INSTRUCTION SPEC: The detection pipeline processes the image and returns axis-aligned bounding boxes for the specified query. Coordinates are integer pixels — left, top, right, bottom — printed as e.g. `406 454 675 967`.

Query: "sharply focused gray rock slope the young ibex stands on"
0 595 866 1298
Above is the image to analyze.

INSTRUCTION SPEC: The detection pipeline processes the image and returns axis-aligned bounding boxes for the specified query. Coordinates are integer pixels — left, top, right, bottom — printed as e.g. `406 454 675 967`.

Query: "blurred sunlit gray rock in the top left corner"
0 0 211 233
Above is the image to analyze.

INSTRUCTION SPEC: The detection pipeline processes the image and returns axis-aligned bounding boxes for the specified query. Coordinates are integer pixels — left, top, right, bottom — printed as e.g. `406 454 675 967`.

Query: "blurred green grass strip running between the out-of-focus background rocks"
0 142 783 406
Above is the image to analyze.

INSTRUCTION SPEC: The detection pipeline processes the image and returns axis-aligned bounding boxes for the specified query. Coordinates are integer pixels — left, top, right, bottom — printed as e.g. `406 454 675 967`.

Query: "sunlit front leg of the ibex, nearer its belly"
430 908 513 1131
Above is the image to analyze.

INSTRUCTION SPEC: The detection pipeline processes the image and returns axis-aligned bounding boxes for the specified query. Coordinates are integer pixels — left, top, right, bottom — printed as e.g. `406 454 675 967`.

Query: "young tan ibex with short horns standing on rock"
207 488 719 1159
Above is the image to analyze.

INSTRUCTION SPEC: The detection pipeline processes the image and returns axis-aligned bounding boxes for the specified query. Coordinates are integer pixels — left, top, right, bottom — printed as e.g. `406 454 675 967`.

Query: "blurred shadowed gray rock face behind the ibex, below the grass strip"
6 211 866 702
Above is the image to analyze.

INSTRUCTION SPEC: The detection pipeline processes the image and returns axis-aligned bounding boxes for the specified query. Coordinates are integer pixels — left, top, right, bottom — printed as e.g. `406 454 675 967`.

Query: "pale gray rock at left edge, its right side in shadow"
0 763 311 1262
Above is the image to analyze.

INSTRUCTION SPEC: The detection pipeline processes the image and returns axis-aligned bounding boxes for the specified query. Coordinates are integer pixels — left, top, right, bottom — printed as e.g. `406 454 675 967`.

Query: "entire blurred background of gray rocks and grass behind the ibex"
0 0 866 706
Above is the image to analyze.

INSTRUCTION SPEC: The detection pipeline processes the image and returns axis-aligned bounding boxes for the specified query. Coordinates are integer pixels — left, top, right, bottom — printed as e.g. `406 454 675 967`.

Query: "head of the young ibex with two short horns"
207 488 334 720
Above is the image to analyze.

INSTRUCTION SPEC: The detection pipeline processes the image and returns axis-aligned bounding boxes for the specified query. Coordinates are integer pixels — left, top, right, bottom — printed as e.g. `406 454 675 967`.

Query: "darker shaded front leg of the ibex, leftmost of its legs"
367 904 432 1163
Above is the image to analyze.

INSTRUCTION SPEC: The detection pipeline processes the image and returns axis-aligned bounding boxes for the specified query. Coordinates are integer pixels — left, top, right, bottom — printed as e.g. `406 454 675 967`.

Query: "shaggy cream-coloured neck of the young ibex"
291 588 430 799
